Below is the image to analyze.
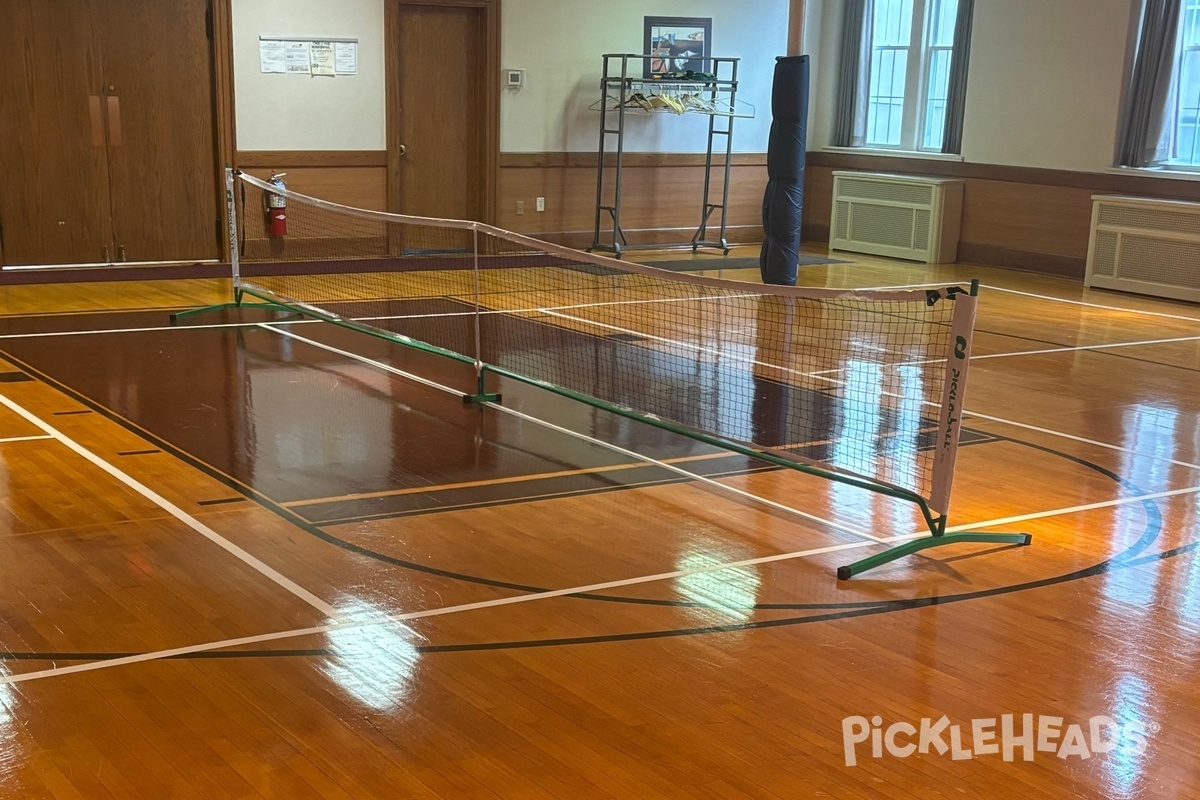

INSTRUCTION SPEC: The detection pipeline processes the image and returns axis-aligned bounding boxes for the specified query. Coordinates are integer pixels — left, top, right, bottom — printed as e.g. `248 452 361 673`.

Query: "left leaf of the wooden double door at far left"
0 0 112 265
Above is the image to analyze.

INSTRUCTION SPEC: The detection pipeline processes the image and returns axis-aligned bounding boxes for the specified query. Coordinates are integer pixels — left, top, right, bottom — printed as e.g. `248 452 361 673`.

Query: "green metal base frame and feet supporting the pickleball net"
177 169 1032 581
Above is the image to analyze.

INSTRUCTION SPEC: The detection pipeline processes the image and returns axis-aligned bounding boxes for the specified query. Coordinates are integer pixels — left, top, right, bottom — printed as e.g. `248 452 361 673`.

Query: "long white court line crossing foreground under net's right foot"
0 474 1200 685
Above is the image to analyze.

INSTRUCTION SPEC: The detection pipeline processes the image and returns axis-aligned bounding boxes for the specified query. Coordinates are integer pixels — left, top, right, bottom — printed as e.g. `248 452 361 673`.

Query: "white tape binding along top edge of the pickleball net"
238 173 949 302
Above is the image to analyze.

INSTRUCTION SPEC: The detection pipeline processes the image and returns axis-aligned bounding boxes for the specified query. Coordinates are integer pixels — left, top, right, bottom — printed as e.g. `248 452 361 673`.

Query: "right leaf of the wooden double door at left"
92 0 221 261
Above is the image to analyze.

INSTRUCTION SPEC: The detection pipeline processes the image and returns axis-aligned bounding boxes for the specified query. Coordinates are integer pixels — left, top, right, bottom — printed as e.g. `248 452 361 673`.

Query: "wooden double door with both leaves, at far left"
0 0 221 265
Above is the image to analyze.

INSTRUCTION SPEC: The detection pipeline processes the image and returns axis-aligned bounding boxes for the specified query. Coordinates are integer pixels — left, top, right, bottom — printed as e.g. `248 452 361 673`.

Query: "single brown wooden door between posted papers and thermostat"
389 2 487 219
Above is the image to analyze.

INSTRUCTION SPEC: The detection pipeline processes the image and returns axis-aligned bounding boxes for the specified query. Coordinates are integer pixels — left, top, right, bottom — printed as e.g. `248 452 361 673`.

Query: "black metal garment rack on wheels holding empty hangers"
588 53 749 258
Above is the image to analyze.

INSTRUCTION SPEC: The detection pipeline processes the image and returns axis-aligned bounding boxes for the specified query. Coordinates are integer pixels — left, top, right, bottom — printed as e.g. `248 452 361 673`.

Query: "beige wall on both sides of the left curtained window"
809 0 1133 172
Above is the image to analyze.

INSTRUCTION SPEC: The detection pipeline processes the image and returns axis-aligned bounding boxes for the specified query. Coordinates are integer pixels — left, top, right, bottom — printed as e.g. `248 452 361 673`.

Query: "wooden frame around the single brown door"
388 0 500 224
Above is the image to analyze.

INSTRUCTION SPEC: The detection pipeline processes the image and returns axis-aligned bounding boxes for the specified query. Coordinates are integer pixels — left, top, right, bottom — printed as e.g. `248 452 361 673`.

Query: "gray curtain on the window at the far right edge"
1117 0 1183 167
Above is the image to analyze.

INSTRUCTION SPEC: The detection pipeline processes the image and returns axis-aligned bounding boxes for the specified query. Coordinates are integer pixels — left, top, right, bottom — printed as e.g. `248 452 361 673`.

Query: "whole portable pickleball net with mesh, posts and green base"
180 170 1028 578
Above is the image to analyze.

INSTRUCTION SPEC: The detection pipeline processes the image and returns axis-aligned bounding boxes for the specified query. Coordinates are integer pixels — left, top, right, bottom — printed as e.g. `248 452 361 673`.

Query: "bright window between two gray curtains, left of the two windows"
865 0 955 151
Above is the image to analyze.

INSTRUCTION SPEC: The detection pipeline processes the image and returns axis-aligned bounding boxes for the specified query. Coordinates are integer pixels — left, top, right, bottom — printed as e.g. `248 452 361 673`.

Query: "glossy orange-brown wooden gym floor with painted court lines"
0 247 1200 799
